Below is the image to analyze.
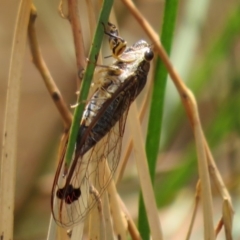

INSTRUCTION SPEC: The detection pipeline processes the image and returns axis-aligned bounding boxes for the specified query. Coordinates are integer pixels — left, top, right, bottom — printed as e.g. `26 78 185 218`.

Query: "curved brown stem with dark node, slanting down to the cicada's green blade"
28 5 72 130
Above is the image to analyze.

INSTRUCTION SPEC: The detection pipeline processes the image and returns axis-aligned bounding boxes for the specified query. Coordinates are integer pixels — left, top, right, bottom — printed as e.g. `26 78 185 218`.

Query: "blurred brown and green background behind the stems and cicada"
0 0 240 240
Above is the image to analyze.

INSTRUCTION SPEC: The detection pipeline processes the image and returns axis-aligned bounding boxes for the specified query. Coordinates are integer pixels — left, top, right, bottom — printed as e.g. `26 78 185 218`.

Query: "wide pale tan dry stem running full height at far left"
0 0 31 239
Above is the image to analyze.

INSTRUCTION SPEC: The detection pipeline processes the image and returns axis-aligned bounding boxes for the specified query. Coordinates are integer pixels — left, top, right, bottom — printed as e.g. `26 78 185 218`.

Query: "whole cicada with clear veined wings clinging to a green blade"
51 23 154 228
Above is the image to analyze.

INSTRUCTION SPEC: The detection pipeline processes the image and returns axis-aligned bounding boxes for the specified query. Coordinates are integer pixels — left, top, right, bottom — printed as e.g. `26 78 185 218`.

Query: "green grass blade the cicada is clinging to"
65 0 113 166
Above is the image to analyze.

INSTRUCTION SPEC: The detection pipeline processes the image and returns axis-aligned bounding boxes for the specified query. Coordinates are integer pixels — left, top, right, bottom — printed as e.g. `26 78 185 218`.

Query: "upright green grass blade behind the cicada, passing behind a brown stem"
138 0 178 240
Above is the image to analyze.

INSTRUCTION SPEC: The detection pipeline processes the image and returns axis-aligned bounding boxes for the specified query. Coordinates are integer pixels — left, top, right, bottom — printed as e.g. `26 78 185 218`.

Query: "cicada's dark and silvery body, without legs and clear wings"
77 42 154 155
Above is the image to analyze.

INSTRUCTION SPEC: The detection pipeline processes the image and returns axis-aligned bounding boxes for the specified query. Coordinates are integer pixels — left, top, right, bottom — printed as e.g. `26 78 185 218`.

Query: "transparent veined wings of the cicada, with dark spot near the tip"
52 106 128 228
